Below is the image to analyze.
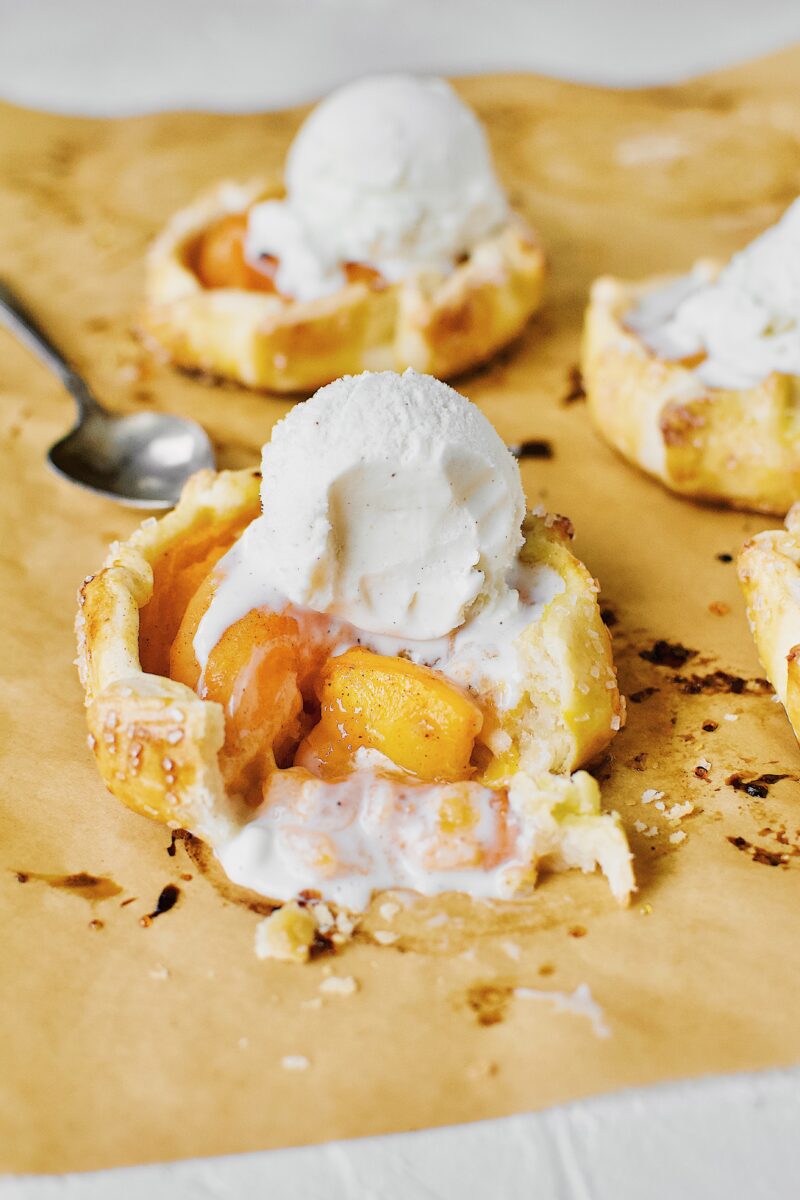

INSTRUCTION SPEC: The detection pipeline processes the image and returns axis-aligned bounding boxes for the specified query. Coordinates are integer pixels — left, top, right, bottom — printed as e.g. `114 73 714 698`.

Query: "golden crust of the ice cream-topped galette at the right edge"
582 277 800 516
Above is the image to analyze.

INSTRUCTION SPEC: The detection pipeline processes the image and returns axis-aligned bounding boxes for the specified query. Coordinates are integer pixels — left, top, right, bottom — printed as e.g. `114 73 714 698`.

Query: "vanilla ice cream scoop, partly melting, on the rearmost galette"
247 74 509 299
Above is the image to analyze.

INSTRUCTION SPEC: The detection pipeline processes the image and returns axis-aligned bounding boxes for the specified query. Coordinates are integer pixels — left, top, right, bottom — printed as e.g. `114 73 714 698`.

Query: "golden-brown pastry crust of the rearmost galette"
140 181 545 392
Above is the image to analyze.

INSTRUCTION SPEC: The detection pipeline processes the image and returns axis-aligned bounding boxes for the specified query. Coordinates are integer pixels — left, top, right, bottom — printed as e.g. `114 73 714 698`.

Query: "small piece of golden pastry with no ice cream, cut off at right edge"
736 504 800 740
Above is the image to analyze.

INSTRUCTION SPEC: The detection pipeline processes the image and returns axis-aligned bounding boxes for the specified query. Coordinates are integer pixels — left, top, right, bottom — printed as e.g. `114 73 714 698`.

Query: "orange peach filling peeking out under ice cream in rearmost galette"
190 212 384 294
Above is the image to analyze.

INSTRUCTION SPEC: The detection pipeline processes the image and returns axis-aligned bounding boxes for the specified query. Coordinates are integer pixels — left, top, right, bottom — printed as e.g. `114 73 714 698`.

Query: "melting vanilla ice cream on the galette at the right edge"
627 199 800 388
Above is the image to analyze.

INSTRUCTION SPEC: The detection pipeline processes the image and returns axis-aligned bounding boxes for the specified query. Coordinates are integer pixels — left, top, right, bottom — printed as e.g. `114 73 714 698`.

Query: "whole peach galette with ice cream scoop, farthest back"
140 76 545 392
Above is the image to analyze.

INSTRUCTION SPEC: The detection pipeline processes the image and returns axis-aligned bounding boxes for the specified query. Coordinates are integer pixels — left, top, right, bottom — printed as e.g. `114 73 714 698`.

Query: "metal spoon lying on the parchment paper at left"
0 281 215 509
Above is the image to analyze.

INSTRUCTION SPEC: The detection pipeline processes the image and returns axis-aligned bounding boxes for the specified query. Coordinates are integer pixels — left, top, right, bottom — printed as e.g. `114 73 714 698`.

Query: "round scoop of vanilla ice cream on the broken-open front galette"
259 371 525 640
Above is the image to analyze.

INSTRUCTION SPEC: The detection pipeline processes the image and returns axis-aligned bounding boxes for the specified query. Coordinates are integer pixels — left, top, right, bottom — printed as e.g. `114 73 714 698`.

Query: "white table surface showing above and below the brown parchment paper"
0 0 800 1200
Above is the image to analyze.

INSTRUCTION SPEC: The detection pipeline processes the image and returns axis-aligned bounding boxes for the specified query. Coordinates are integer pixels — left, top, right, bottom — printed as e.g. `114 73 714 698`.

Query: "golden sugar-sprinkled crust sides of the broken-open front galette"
77 470 624 845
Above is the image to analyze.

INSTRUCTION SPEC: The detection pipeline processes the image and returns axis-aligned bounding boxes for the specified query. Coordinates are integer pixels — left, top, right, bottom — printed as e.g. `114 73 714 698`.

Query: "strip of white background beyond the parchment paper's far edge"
0 0 800 113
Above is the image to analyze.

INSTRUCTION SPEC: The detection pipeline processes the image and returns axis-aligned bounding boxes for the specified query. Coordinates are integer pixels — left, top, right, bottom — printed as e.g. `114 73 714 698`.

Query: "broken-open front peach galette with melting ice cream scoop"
78 371 633 950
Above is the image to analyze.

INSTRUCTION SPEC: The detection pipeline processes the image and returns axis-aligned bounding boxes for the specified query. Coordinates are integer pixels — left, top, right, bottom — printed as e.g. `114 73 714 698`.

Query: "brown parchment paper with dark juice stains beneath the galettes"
0 50 800 1171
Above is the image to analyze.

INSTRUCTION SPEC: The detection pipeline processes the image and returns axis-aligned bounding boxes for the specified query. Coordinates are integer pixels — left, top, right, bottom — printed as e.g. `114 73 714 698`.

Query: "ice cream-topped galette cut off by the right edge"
582 200 800 515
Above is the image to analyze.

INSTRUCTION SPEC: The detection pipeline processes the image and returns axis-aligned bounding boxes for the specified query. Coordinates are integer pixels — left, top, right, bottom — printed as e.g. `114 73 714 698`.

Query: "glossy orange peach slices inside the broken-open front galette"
169 556 483 804
